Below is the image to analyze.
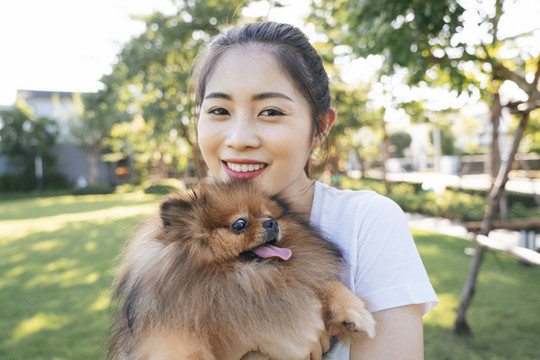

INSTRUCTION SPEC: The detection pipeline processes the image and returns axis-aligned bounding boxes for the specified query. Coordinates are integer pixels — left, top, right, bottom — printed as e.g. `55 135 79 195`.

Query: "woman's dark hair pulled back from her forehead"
194 22 330 176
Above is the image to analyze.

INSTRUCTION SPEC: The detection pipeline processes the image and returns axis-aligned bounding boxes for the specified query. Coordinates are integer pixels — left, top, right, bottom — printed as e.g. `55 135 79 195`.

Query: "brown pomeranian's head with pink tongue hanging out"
160 181 290 263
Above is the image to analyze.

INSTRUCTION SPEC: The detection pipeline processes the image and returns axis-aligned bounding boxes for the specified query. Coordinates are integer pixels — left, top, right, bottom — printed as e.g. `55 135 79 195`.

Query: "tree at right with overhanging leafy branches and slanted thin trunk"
313 0 540 332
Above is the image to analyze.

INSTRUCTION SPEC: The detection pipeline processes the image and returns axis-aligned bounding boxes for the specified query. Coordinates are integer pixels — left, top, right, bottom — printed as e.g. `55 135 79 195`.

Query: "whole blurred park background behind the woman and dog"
0 0 540 359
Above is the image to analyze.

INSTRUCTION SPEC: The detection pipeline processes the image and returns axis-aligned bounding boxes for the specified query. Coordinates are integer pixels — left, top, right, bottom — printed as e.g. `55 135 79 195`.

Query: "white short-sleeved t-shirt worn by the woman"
310 181 439 360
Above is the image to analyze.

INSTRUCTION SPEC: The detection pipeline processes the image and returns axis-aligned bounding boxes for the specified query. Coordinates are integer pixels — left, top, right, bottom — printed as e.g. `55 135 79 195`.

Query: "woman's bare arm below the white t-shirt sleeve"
351 305 424 360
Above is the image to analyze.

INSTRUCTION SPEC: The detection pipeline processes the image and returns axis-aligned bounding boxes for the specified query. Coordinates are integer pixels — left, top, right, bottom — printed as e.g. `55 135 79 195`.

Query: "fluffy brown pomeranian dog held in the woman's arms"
109 181 375 360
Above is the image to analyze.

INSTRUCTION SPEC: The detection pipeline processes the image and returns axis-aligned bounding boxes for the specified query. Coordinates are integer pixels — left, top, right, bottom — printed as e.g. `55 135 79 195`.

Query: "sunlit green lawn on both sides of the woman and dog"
0 194 540 360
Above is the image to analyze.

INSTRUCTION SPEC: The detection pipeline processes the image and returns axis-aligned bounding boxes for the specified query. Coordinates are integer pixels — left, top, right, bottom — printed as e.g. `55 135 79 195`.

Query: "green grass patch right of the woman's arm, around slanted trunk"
420 231 540 360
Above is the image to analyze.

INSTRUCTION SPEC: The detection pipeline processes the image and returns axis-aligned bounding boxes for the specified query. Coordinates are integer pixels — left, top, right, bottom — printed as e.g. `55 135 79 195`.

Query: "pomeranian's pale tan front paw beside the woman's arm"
323 281 375 342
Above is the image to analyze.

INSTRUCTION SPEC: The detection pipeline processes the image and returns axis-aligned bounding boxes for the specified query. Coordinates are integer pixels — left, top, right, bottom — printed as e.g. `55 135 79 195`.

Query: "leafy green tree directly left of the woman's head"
93 0 246 177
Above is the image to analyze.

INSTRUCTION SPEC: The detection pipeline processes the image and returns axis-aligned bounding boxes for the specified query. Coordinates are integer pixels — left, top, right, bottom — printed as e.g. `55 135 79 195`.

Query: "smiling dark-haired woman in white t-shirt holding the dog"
195 22 437 359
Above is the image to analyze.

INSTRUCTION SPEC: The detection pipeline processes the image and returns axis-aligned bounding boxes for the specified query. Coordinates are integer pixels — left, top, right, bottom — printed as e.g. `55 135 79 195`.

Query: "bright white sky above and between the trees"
0 0 540 106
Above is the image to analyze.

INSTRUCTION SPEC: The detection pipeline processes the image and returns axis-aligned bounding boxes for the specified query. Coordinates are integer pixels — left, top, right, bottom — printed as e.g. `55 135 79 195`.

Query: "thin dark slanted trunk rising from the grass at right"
454 112 529 334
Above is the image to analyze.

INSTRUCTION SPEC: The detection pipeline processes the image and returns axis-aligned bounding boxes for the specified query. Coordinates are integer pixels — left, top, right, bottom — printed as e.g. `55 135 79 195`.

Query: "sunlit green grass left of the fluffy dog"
0 194 156 360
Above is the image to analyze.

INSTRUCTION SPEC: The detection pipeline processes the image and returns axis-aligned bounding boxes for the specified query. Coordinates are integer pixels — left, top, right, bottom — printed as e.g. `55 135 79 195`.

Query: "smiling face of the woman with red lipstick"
198 47 314 194
